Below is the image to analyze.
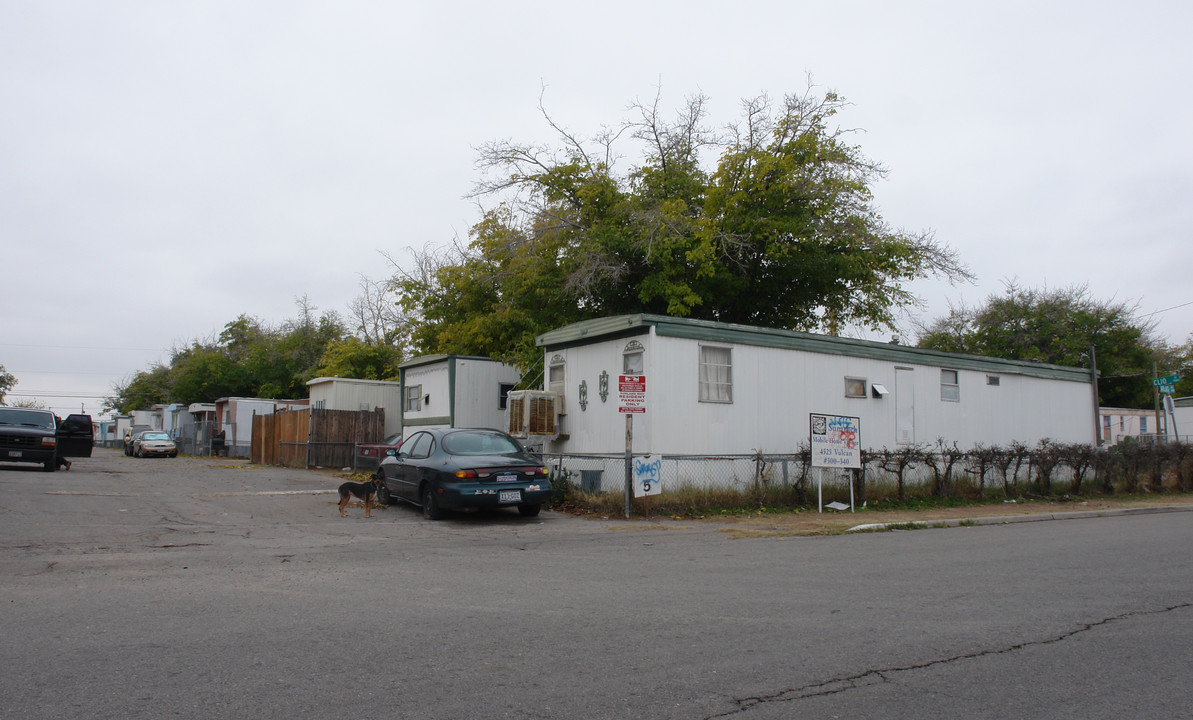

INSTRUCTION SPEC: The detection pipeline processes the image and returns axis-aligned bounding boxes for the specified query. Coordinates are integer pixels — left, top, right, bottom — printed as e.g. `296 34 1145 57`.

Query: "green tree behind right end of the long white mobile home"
919 283 1164 408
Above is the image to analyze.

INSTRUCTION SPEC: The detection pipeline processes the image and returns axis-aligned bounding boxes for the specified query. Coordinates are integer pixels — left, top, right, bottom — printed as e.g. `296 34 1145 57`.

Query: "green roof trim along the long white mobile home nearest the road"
534 314 1090 383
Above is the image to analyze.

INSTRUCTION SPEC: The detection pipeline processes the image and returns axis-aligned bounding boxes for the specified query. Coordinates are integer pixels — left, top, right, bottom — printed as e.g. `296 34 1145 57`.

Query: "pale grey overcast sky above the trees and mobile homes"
0 0 1193 414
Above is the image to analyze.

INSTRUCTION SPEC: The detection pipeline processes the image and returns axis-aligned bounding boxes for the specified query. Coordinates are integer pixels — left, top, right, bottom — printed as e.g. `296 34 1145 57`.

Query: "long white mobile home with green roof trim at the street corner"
537 315 1098 454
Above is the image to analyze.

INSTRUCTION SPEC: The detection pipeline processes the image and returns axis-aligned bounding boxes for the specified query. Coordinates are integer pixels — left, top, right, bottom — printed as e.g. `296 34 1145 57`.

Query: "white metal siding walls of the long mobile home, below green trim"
546 334 1094 454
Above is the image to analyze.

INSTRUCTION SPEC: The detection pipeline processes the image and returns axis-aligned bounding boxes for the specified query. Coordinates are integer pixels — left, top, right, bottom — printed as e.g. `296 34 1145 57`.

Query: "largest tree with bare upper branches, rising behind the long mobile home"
395 91 970 371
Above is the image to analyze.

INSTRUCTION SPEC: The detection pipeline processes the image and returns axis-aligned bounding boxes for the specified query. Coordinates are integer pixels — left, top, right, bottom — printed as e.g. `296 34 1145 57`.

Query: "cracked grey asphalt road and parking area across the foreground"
0 451 1193 720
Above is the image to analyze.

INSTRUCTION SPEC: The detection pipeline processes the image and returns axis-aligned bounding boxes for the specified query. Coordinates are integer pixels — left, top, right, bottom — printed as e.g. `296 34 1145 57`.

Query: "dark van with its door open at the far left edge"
0 408 93 472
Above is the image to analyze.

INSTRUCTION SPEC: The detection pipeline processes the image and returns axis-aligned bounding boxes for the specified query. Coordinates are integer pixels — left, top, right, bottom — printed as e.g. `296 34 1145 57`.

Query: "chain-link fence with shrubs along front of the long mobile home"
539 442 1193 504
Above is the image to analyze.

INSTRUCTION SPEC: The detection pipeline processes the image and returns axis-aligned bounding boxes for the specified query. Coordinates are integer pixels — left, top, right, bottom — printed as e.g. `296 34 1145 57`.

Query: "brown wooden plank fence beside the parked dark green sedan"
251 408 385 467
